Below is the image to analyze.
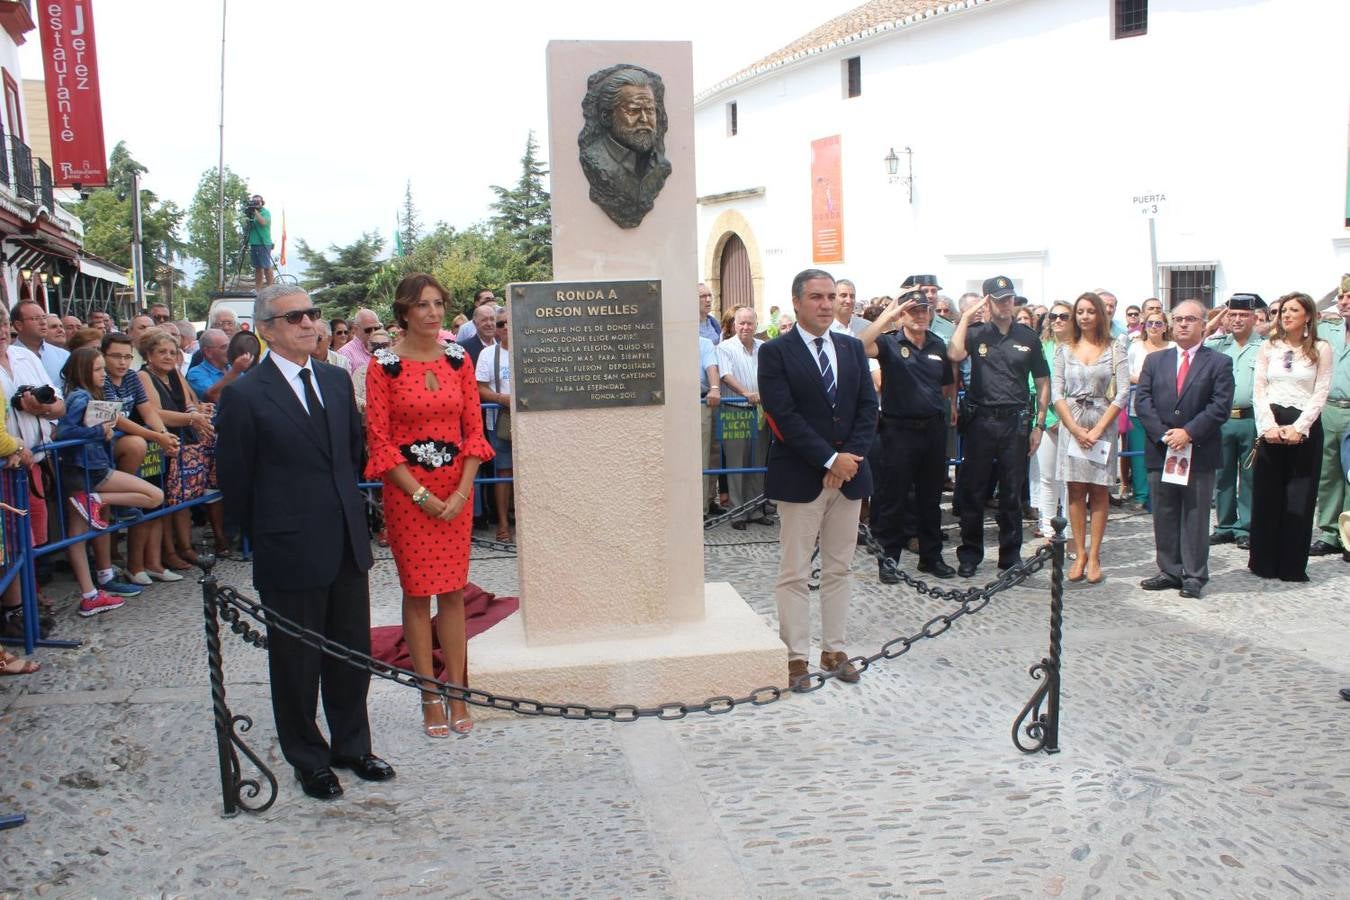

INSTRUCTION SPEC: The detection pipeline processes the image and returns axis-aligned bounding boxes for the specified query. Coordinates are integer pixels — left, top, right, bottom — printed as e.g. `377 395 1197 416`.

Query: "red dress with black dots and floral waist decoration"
366 354 493 596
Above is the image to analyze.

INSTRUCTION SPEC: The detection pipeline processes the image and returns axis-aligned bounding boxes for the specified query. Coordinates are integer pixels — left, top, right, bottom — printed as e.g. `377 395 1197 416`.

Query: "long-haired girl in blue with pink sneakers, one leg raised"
55 347 165 617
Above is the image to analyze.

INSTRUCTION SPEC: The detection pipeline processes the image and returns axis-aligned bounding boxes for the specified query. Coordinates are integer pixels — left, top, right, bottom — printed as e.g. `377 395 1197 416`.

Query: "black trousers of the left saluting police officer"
876 414 946 561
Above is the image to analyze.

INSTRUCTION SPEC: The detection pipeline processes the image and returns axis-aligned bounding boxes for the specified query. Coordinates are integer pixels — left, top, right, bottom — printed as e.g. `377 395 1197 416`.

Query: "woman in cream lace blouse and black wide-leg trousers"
1247 293 1332 582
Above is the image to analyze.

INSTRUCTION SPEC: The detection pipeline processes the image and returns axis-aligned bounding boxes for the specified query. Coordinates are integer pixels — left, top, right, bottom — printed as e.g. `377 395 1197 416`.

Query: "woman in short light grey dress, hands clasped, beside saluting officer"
1050 291 1130 584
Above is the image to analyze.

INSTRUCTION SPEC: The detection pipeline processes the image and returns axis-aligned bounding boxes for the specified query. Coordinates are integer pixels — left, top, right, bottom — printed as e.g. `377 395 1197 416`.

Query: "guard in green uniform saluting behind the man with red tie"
1206 294 1266 549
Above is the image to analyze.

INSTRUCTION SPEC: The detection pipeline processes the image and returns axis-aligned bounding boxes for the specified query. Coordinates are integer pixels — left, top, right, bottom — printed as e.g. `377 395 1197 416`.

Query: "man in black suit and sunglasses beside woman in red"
216 285 394 800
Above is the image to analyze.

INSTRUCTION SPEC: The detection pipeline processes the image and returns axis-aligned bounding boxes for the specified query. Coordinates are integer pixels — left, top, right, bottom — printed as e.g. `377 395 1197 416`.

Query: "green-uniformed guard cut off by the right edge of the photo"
1308 278 1350 560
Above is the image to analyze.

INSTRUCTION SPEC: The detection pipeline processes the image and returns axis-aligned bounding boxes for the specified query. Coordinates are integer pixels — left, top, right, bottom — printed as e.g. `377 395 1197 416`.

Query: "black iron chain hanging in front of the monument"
208 533 1052 722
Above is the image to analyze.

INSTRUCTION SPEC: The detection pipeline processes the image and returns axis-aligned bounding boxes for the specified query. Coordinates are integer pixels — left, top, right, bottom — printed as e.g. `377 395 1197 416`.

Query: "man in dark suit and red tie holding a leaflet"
1135 300 1234 598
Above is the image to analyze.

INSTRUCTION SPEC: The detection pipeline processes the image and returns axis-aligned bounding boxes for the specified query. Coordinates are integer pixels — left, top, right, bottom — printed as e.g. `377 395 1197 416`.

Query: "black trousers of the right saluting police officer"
956 412 1029 568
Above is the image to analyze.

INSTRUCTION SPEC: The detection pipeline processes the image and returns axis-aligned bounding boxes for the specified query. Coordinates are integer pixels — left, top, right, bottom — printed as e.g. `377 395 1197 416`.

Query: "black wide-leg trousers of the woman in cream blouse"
1247 405 1322 582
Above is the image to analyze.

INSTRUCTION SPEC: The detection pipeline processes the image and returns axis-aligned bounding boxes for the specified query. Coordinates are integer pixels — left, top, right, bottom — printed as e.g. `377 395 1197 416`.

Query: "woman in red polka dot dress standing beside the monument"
366 274 493 738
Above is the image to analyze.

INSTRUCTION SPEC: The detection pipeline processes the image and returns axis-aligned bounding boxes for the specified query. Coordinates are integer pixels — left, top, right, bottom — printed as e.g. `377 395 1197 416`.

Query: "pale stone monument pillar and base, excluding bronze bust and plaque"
470 40 787 706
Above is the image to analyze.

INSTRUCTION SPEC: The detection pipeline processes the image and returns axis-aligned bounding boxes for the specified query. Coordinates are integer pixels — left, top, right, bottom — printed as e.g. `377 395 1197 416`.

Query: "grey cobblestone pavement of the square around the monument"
0 517 1350 897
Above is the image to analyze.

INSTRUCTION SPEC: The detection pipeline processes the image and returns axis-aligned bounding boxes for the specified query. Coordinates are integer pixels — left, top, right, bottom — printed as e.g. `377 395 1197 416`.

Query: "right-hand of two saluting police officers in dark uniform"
948 275 1050 578
